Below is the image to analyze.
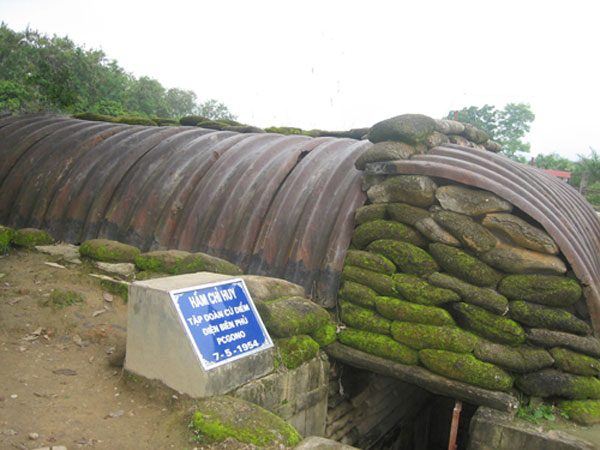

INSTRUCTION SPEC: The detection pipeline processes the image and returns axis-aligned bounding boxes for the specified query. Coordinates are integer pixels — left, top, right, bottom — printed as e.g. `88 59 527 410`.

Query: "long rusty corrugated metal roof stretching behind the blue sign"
0 115 371 304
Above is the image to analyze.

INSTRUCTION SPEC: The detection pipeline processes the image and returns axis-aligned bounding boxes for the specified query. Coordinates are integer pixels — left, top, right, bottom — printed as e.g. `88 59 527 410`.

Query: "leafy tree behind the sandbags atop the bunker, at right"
446 103 535 162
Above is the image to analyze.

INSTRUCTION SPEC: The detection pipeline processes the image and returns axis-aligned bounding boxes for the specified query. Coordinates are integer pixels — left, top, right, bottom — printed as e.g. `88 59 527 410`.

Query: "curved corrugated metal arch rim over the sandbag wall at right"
367 145 600 336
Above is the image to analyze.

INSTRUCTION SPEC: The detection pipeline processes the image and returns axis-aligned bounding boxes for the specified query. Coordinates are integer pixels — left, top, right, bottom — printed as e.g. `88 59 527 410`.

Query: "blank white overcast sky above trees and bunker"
0 0 600 160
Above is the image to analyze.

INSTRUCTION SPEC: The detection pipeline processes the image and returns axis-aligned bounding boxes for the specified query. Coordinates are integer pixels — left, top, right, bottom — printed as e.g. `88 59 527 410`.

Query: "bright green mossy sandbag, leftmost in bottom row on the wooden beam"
338 328 419 365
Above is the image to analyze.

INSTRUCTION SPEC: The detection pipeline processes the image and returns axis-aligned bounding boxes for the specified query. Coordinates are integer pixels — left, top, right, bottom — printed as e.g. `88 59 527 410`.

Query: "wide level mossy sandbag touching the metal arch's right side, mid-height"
498 274 582 307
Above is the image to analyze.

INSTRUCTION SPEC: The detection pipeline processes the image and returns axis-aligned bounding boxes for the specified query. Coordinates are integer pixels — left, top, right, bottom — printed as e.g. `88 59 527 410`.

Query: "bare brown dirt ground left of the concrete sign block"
0 250 200 450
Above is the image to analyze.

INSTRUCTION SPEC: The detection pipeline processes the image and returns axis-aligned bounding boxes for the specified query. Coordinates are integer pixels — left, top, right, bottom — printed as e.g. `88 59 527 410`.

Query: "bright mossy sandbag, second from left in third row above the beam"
375 297 456 326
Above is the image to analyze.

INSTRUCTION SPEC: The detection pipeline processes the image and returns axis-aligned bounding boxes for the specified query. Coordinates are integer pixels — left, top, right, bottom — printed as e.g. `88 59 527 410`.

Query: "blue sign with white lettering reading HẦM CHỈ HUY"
169 279 273 370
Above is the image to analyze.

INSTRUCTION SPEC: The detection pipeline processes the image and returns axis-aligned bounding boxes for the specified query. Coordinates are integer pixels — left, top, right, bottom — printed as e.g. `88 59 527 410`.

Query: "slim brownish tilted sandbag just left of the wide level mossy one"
427 272 508 315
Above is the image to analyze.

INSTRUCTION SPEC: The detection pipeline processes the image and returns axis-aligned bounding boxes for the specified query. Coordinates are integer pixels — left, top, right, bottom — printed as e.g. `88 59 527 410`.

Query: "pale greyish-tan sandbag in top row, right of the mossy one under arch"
435 185 512 216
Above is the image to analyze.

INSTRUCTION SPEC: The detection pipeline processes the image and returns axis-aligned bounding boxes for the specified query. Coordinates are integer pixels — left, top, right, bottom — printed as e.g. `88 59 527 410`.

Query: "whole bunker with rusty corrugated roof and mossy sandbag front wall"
0 111 600 449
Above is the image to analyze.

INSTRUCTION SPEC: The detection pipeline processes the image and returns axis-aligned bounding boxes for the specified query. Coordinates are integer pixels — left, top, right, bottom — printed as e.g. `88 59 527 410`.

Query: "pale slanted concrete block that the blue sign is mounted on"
125 272 273 397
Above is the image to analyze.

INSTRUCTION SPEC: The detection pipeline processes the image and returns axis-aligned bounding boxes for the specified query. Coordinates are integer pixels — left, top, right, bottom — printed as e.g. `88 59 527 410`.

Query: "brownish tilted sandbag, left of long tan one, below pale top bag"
433 211 498 253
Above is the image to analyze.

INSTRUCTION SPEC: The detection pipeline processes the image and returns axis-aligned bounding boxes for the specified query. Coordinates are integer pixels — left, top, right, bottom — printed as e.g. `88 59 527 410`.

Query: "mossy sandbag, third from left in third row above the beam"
453 302 525 346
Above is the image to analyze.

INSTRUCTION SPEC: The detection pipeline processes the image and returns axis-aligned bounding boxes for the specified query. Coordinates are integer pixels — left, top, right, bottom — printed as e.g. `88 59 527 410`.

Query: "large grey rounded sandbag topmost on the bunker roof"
369 114 435 144
